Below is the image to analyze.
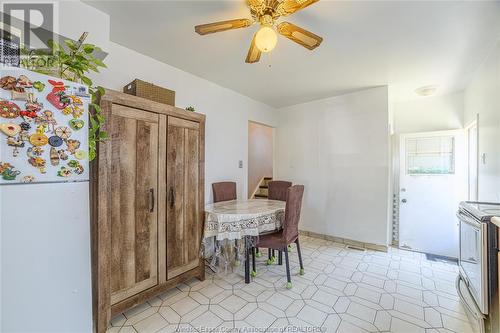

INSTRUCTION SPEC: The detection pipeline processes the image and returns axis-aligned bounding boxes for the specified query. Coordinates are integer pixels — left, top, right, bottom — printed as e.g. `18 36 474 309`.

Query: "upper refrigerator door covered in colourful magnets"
0 67 90 185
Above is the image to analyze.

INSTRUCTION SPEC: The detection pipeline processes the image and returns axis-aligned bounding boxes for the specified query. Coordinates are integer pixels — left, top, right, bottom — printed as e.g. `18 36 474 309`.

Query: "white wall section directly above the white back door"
393 92 464 133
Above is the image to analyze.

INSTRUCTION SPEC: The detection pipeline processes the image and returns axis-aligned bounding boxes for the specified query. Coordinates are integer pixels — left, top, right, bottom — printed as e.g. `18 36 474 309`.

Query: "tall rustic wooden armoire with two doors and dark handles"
91 90 205 333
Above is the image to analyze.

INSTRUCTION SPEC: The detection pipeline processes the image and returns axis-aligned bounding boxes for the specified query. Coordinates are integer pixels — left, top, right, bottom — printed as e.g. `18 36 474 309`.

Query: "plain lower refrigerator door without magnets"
0 182 92 333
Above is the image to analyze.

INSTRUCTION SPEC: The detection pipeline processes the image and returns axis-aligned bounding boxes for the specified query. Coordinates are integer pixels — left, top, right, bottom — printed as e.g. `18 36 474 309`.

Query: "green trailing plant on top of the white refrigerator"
23 33 108 161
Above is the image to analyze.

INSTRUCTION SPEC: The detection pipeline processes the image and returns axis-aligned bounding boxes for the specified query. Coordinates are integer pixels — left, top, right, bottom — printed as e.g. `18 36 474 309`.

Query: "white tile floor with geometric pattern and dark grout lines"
108 237 472 333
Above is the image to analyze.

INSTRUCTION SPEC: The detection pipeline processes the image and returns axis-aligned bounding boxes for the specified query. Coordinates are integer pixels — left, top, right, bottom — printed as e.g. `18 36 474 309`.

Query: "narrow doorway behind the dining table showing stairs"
248 121 274 198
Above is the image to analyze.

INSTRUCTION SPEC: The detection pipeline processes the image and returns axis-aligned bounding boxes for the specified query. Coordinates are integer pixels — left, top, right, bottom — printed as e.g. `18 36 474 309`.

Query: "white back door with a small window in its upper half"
399 130 467 258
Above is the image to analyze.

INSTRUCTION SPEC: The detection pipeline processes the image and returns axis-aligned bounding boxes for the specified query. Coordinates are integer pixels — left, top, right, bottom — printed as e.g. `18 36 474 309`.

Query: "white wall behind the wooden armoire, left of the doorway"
59 1 276 202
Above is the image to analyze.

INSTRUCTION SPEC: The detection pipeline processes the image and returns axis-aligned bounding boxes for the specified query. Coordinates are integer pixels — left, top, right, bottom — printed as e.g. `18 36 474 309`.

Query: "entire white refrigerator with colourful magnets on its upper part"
0 67 92 333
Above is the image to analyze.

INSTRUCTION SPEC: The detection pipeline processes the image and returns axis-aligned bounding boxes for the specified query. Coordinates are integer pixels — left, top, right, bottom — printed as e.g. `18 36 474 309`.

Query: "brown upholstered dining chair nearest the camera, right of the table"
252 185 304 289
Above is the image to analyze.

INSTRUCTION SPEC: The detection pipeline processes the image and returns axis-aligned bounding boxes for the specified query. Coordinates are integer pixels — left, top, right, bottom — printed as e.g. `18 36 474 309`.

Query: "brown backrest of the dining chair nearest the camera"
283 185 304 244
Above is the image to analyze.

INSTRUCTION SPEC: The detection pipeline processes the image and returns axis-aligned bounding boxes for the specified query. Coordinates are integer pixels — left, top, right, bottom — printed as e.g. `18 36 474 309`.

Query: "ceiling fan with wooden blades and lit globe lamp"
194 0 323 63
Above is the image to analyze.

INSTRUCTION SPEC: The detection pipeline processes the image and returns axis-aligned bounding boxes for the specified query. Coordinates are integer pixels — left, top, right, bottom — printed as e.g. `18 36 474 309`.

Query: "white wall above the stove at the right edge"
465 42 500 202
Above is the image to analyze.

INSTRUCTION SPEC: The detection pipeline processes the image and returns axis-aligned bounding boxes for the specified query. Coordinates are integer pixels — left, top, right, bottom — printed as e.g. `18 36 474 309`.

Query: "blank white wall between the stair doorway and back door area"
276 87 390 245
